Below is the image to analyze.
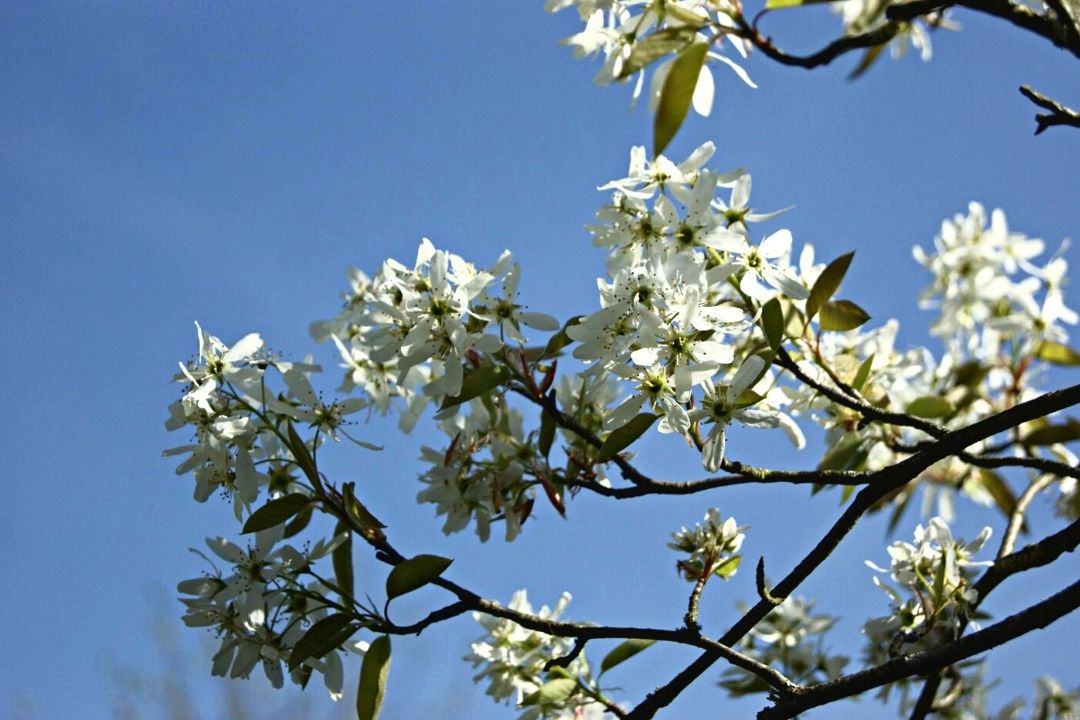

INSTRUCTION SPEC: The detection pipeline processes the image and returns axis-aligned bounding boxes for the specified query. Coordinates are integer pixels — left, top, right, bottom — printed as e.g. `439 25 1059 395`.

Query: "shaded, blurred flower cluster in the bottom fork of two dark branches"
720 597 848 695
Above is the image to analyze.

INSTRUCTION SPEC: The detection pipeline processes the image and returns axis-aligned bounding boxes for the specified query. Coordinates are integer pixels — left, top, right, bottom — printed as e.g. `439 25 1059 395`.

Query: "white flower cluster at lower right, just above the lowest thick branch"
863 517 991 664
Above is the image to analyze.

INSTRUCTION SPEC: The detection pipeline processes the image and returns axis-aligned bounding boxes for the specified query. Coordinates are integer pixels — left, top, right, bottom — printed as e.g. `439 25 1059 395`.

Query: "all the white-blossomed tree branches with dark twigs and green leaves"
166 0 1080 720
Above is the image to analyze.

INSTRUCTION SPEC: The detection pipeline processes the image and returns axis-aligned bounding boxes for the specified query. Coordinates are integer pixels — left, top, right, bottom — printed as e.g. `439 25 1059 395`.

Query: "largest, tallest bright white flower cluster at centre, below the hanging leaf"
566 142 809 471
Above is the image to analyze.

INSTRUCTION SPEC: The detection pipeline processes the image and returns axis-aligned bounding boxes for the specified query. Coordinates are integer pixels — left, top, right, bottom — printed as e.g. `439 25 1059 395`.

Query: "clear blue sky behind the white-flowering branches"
0 2 1080 718
